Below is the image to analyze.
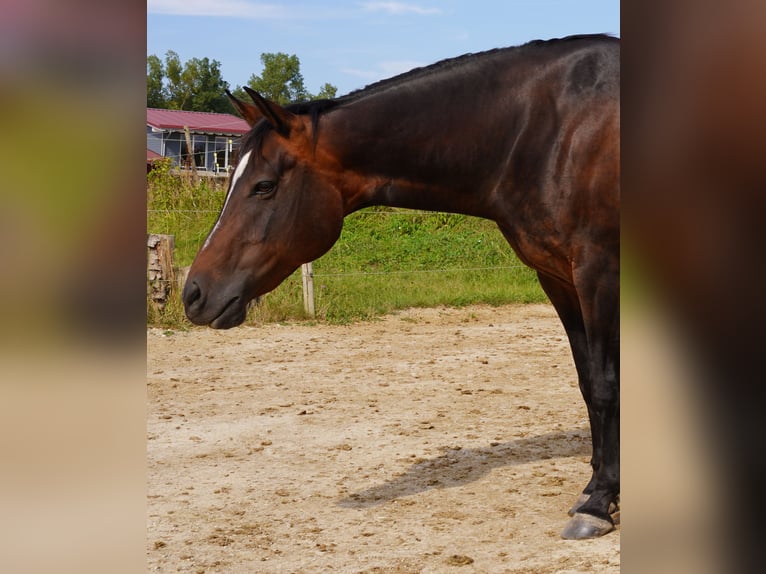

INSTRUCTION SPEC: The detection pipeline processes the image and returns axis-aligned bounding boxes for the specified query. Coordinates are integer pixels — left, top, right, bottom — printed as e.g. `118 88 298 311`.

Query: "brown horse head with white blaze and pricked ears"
183 92 344 329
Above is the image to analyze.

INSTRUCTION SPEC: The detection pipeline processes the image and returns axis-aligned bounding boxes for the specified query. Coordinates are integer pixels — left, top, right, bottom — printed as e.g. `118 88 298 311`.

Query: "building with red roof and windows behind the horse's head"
146 108 250 173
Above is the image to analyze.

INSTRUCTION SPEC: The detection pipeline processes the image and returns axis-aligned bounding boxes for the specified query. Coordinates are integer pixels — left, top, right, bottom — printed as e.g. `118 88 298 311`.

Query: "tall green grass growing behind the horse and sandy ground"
147 164 547 328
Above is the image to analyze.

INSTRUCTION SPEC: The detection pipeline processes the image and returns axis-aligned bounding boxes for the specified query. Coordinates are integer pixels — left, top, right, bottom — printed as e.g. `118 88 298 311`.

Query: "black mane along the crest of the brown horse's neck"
239 34 619 160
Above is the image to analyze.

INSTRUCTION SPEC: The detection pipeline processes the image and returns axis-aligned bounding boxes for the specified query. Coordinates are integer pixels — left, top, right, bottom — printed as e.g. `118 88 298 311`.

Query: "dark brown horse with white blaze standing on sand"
183 36 620 538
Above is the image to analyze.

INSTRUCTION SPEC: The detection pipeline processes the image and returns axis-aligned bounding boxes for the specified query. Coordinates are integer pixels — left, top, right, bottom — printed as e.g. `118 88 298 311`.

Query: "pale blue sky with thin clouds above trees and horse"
147 0 620 96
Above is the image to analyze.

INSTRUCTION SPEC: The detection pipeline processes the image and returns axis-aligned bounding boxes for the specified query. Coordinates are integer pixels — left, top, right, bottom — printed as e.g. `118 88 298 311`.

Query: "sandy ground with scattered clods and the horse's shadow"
147 305 620 573
